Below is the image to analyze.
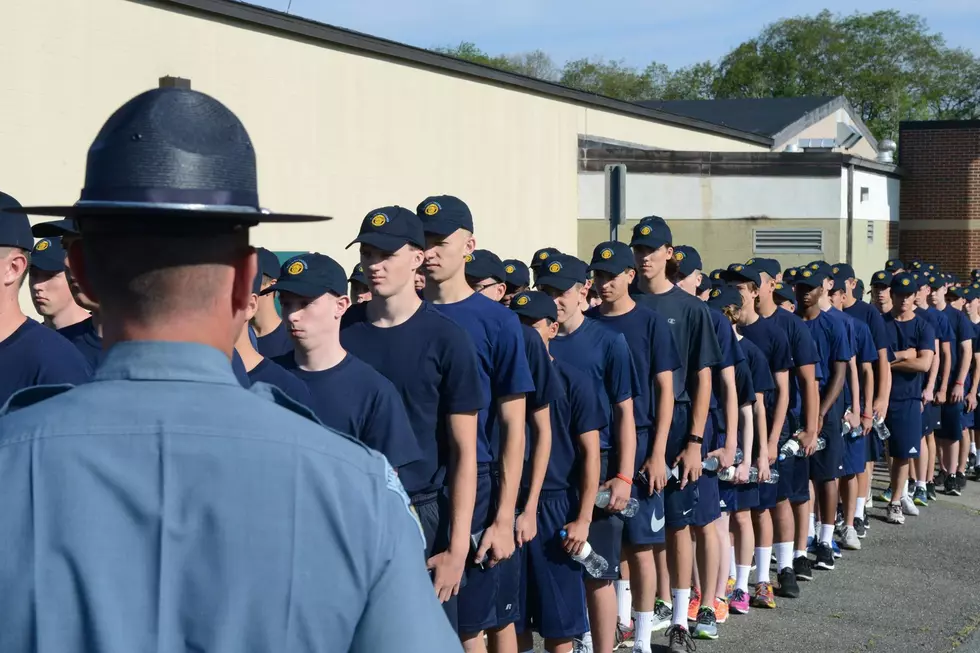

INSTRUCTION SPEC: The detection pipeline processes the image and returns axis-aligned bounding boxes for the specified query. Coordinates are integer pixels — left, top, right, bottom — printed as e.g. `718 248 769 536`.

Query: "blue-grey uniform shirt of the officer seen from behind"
0 342 460 653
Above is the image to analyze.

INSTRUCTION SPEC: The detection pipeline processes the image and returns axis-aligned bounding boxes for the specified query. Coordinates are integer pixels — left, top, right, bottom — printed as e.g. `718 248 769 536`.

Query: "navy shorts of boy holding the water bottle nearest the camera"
517 490 591 639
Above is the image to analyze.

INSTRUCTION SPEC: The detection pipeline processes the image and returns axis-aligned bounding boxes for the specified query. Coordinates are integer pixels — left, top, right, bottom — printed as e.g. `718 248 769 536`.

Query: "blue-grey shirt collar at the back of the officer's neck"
94 340 239 386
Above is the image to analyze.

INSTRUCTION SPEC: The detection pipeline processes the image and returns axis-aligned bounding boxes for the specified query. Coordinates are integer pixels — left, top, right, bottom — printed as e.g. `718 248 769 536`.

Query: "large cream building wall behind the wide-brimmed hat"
0 0 765 316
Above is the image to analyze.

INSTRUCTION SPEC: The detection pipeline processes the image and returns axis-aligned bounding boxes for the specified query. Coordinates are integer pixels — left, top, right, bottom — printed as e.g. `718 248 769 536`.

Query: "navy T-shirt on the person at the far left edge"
0 318 92 406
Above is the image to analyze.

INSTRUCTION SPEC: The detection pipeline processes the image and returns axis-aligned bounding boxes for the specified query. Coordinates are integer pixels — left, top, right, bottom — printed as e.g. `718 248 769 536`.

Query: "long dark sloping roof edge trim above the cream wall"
145 0 772 147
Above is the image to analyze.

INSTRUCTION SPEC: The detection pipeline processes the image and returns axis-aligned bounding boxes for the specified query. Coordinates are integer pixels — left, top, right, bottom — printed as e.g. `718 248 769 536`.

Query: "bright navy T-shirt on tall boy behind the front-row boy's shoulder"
432 293 534 463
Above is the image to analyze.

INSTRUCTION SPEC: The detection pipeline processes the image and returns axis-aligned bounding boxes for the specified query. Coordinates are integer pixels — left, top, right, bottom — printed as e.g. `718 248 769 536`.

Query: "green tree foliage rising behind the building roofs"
437 10 980 138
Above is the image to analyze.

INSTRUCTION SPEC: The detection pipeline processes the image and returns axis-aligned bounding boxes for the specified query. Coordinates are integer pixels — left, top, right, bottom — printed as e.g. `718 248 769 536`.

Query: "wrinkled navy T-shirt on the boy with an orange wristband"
549 318 639 449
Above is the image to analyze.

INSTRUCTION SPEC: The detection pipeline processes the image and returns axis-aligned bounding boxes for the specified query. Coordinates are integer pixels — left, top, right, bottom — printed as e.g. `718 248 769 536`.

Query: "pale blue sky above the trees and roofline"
250 0 980 68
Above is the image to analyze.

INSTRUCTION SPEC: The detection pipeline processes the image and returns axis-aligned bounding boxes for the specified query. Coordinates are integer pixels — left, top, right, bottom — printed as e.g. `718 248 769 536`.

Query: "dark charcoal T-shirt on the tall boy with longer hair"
633 286 721 403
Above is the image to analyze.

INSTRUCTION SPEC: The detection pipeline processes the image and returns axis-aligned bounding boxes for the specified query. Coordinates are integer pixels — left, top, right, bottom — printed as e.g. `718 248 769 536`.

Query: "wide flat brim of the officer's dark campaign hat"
6 202 333 224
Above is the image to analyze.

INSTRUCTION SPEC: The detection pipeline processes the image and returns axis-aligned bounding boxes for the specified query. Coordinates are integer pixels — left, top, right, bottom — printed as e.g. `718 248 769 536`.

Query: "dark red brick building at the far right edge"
899 120 980 277
